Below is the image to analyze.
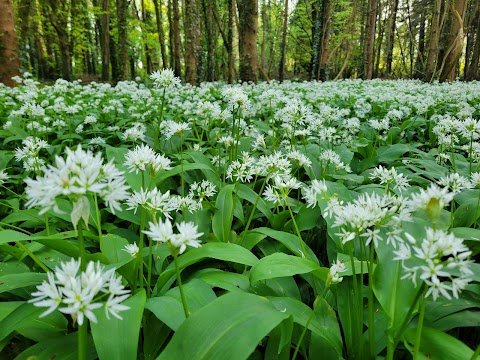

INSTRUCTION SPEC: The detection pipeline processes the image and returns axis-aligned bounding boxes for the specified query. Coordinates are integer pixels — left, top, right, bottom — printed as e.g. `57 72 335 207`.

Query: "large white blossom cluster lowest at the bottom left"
29 259 130 325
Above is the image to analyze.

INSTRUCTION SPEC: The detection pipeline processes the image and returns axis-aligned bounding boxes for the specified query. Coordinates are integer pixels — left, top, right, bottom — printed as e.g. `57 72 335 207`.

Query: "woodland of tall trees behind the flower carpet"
0 0 480 84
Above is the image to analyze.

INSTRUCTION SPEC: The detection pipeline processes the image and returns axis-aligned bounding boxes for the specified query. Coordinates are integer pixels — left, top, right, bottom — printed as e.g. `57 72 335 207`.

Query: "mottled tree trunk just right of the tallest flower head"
184 0 201 85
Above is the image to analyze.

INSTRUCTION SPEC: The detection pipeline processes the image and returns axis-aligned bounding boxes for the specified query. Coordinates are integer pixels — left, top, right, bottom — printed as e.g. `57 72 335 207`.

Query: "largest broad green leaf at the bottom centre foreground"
157 292 288 360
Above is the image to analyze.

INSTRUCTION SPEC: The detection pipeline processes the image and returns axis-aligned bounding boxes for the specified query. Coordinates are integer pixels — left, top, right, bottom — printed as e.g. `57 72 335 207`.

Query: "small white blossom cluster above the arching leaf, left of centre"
144 219 203 254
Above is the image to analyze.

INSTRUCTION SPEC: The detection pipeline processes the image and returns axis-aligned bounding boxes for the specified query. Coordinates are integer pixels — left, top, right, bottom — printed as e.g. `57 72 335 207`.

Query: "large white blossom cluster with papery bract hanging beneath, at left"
25 145 128 227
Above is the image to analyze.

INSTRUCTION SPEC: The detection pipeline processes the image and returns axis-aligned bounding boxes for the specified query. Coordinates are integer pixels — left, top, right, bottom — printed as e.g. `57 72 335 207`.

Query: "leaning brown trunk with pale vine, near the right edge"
440 0 467 81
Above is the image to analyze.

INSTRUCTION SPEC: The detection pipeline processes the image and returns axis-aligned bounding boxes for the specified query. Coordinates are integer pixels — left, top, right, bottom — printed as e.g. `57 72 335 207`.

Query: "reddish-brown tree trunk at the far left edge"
0 0 20 86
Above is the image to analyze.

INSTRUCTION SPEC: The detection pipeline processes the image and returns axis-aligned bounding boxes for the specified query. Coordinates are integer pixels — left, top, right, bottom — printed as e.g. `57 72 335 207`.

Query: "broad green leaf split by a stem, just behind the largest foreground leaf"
145 279 217 331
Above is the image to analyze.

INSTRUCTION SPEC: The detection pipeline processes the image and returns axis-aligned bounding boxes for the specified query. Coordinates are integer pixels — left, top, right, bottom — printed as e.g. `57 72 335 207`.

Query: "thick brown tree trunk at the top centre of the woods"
237 0 258 82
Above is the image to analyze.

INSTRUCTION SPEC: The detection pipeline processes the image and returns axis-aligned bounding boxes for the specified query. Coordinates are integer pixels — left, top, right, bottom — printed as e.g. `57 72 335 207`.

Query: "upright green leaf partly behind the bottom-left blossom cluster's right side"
90 289 147 360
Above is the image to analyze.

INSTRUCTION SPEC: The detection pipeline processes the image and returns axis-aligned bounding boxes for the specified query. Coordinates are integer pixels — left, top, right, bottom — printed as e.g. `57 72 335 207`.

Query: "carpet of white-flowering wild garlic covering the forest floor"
0 71 480 359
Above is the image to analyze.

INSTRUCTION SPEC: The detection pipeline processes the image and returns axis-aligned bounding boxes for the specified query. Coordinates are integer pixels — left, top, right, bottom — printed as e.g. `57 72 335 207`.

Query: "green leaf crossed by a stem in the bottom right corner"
405 327 473 360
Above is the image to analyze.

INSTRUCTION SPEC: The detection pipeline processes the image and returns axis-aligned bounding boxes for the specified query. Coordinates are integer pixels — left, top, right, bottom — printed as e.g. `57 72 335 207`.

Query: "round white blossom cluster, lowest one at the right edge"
394 228 473 300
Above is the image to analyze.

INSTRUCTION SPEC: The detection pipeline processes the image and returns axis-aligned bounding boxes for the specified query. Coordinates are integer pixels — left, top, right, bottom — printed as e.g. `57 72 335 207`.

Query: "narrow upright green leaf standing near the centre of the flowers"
212 184 234 243
